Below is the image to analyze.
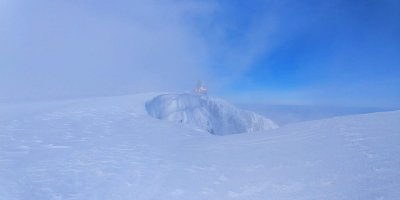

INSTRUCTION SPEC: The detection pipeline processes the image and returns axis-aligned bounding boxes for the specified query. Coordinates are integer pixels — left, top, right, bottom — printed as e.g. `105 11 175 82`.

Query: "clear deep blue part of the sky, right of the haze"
208 1 400 106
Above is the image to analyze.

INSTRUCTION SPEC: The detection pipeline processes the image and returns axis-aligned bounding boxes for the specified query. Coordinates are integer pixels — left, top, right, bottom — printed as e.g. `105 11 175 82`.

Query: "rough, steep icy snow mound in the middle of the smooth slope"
146 93 278 135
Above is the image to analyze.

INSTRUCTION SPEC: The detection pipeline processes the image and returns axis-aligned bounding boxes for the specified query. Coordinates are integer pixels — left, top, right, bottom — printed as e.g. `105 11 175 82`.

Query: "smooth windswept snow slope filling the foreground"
0 94 400 200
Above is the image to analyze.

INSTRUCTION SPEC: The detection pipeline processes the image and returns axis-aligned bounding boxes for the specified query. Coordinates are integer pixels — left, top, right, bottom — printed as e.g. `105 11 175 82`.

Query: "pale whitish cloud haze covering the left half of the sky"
0 0 216 101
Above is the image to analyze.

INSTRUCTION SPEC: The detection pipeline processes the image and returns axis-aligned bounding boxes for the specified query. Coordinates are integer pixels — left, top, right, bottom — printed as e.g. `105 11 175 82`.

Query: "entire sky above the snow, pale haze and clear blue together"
0 0 400 107
